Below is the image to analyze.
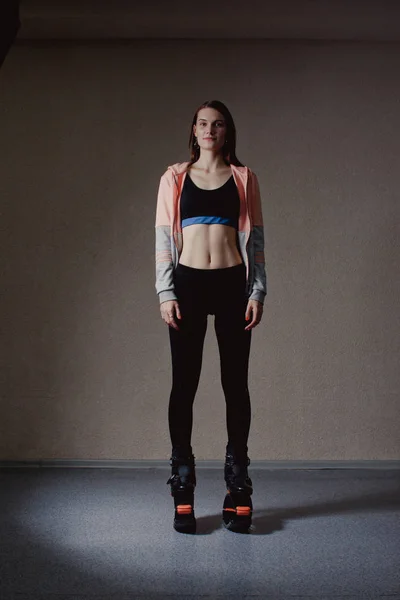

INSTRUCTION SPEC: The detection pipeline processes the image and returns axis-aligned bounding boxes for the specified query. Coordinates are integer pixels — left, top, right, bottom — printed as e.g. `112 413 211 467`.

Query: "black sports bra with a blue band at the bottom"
180 173 240 229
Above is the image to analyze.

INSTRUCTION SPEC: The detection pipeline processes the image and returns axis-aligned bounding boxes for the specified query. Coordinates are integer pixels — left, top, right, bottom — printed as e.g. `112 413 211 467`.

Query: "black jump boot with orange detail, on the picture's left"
167 454 196 533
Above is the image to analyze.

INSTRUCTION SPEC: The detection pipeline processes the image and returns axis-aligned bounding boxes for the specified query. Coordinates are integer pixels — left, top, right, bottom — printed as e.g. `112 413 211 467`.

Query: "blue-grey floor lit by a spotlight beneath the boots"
0 467 400 600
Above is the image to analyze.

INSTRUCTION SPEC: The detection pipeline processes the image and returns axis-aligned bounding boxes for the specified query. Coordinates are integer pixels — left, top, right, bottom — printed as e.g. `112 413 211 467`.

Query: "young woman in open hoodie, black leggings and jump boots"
155 100 267 533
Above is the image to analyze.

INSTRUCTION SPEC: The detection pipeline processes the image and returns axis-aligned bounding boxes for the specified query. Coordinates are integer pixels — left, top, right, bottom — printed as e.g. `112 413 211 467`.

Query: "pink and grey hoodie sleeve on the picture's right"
249 171 267 303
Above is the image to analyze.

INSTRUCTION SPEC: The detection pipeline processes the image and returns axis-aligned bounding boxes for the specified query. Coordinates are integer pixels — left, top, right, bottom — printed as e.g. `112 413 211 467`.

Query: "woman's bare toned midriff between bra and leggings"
179 223 243 269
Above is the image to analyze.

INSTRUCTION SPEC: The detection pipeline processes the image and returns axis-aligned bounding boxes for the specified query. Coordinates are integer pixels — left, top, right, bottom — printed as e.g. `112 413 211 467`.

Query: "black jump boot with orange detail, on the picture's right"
222 452 253 533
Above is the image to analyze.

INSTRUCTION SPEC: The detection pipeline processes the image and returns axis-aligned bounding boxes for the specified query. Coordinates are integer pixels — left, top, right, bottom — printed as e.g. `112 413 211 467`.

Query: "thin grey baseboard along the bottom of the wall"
0 458 400 470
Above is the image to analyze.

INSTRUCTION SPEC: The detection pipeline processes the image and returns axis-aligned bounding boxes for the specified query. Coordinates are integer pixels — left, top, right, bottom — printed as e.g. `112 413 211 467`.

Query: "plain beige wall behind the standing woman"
0 40 400 460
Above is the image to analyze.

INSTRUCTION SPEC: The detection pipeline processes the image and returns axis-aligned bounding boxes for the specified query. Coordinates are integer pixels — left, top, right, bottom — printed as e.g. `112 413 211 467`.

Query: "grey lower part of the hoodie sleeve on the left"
155 225 177 304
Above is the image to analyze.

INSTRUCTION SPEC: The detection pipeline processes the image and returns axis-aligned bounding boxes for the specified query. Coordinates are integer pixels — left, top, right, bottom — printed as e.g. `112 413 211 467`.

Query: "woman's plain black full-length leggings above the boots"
168 263 251 454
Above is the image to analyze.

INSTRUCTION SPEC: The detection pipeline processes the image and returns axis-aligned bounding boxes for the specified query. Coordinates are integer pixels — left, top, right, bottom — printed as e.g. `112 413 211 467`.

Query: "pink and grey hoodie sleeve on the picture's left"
155 171 177 304
